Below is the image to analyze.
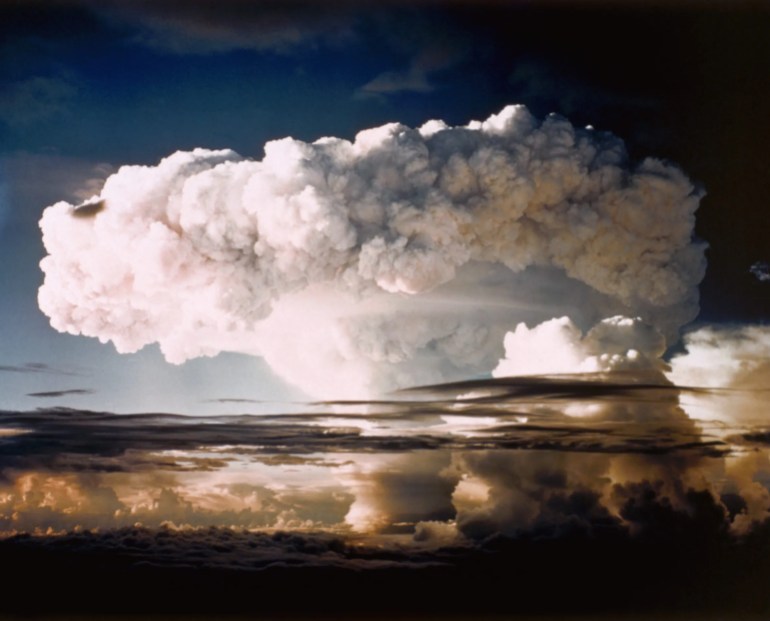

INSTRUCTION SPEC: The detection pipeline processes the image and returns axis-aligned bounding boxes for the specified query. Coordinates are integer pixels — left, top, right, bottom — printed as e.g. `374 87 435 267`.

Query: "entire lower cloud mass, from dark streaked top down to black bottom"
0 373 770 619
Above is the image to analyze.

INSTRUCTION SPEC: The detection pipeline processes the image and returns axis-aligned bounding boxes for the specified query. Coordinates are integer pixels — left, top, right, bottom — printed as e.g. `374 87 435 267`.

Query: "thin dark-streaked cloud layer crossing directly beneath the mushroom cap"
0 377 724 490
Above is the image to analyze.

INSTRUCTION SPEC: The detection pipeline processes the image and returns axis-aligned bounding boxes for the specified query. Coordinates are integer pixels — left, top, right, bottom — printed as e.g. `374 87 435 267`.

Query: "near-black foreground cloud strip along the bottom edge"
0 520 770 619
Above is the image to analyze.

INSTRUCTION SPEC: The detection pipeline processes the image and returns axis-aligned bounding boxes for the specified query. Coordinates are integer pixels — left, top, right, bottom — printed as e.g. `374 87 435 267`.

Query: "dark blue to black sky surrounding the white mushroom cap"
0 0 770 410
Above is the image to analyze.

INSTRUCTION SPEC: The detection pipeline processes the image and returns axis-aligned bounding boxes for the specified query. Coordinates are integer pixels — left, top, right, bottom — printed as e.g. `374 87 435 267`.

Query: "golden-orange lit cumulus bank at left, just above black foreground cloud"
0 455 353 536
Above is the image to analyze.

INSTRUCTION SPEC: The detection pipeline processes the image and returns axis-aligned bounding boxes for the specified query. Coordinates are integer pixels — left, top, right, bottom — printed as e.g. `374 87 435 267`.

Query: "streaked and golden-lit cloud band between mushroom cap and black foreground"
0 372 770 536
